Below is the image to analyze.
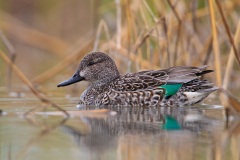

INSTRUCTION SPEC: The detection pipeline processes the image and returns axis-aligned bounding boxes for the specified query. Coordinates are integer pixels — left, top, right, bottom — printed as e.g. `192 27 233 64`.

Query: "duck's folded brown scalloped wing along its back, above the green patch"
111 66 212 91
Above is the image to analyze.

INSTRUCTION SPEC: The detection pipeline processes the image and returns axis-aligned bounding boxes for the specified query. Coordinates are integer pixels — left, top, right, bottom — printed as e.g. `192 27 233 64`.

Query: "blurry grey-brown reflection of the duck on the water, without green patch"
61 107 221 159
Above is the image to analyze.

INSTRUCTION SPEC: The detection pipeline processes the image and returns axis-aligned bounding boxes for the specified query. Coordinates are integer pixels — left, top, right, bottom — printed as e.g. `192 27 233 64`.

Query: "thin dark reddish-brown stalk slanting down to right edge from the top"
216 0 240 65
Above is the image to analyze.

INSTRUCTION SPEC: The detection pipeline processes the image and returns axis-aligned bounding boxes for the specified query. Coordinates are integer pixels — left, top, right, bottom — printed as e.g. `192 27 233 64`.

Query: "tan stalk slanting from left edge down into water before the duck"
0 50 69 117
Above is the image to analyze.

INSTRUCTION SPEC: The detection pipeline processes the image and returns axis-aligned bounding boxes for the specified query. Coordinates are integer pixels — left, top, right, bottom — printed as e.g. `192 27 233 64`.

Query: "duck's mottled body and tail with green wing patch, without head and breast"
97 66 216 106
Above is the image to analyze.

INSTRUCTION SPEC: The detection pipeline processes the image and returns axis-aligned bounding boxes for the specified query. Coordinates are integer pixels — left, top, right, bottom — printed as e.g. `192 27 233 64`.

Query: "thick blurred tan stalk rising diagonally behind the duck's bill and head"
32 40 93 83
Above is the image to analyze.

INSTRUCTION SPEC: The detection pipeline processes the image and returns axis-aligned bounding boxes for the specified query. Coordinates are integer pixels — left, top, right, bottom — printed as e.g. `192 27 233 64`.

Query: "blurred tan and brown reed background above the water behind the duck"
0 0 240 98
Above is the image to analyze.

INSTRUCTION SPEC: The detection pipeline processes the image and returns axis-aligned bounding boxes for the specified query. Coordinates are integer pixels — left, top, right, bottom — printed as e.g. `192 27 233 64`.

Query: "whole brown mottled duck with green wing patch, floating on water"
58 52 217 107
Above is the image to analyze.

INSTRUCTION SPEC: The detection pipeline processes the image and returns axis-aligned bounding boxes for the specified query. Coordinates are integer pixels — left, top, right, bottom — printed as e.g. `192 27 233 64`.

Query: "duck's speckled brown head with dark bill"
58 52 120 87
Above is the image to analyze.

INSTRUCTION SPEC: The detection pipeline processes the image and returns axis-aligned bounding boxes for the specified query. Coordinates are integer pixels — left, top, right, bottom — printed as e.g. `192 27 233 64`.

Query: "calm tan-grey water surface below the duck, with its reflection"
0 94 240 160
